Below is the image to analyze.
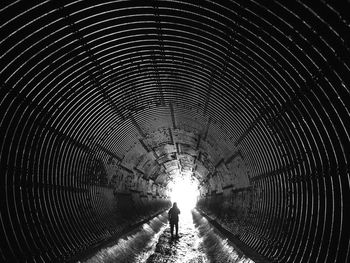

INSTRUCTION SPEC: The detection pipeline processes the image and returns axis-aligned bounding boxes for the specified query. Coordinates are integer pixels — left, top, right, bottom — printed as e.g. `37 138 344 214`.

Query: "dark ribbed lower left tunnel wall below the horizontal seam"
1 155 170 262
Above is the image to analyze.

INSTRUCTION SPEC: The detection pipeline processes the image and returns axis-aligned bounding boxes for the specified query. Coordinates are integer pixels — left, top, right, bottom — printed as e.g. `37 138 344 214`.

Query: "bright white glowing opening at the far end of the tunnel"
169 174 199 212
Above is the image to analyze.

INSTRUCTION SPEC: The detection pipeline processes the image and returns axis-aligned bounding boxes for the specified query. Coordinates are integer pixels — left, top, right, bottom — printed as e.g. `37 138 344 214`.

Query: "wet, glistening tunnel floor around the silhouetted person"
81 210 254 263
